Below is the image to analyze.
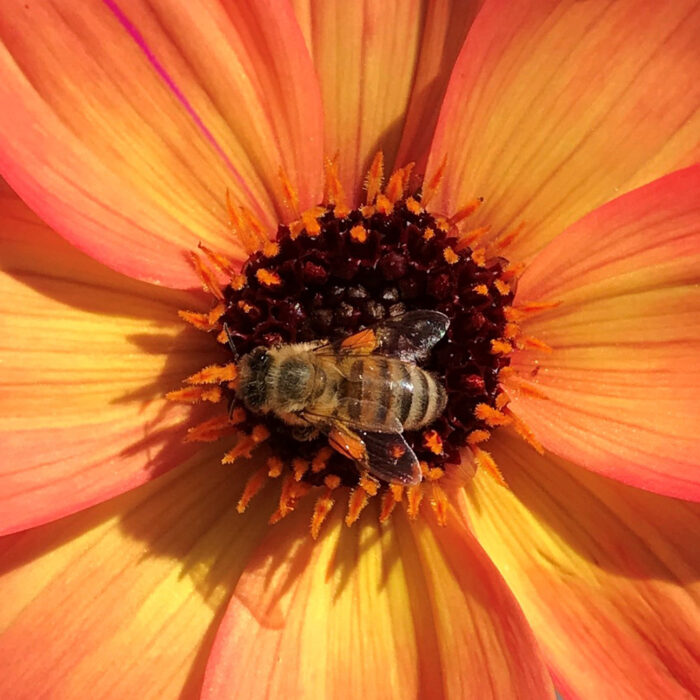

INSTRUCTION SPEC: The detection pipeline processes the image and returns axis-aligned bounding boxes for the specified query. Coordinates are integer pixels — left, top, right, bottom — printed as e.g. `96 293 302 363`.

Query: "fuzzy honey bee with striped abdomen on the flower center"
227 310 450 485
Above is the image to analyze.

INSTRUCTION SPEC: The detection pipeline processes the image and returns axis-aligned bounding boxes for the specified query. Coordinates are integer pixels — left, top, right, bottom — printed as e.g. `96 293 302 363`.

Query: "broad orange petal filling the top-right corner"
426 0 700 260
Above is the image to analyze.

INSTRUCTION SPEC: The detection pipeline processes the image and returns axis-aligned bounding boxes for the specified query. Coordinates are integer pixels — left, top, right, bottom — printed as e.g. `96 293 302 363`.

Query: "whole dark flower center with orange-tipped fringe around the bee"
169 157 540 536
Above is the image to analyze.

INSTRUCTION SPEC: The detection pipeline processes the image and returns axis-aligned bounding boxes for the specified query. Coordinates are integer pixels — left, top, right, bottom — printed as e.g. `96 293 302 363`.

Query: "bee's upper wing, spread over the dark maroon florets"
313 309 450 362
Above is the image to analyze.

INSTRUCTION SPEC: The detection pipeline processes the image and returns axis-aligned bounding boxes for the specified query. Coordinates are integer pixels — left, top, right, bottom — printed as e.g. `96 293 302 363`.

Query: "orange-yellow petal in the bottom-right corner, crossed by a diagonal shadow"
467 431 700 698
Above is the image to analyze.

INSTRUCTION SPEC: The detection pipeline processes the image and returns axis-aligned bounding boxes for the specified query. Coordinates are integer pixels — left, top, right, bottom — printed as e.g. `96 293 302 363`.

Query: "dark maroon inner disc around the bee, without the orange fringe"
222 200 513 487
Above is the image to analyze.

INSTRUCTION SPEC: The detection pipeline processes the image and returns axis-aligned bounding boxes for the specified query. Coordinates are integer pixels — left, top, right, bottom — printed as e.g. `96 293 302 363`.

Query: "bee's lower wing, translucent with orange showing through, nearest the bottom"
328 421 421 486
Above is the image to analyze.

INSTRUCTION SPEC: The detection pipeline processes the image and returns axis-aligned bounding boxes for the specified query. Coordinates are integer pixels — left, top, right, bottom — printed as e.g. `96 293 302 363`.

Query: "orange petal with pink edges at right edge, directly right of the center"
510 166 700 500
